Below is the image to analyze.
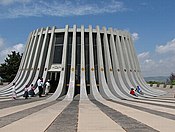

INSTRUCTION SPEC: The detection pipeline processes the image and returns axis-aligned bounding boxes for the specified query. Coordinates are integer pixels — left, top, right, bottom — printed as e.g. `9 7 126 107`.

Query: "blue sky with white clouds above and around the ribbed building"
0 0 175 77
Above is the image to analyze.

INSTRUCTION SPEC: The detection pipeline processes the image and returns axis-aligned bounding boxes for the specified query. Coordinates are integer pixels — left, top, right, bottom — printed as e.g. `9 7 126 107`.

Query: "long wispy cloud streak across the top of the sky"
0 0 126 19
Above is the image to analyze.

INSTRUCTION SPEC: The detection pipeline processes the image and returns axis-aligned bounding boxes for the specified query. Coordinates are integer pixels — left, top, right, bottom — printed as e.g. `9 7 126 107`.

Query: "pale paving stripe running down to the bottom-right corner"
97 101 175 132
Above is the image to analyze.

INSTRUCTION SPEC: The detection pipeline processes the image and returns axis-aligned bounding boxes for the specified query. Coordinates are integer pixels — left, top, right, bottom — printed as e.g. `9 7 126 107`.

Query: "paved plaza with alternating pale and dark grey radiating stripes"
0 85 175 132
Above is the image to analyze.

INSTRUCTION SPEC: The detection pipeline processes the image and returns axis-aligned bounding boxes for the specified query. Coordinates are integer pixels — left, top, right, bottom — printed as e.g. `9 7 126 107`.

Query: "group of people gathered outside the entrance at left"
11 77 50 99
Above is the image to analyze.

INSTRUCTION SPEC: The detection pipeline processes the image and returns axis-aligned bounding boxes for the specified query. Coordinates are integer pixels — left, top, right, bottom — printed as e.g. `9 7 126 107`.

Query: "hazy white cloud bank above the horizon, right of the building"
138 39 175 76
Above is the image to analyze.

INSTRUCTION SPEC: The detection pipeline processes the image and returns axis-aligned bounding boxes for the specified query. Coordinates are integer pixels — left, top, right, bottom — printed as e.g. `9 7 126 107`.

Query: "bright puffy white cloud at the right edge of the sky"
156 39 175 54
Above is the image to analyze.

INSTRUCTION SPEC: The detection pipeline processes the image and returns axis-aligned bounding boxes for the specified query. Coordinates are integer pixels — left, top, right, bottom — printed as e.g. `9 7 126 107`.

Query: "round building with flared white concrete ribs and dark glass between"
0 25 164 100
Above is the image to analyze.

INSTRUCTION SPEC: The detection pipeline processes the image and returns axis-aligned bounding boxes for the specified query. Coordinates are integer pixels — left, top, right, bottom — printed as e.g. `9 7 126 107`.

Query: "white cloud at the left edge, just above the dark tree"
0 43 25 64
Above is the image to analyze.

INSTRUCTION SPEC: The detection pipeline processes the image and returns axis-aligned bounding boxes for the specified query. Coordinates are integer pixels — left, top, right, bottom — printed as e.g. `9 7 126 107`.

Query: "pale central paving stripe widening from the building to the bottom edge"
78 101 125 132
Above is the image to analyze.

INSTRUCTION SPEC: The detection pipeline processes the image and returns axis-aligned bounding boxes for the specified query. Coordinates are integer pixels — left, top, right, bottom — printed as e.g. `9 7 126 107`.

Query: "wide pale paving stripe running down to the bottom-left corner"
0 101 70 132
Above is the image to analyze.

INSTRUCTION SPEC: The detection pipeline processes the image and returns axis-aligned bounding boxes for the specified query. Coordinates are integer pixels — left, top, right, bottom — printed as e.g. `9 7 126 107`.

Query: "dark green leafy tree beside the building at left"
0 51 22 82
